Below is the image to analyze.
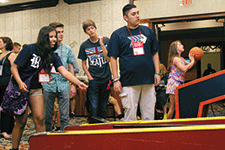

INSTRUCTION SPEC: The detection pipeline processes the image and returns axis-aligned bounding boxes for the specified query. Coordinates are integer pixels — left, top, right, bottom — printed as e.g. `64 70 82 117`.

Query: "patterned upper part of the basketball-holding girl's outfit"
169 59 185 82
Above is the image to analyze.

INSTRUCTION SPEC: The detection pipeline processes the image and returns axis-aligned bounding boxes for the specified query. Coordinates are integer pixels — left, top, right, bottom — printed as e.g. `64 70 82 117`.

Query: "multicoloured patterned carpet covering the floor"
0 103 225 150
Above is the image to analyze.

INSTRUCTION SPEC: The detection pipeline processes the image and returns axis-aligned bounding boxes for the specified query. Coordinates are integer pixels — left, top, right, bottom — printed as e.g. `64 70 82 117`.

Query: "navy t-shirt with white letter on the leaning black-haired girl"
12 44 63 89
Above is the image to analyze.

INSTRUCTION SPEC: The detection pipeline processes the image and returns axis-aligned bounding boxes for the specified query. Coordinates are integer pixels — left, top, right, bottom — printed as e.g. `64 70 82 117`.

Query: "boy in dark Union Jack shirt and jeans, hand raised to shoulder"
78 20 111 123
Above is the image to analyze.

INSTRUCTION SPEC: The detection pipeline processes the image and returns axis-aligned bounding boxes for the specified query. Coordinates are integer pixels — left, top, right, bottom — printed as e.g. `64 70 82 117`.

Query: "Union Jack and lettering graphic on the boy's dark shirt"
85 46 107 67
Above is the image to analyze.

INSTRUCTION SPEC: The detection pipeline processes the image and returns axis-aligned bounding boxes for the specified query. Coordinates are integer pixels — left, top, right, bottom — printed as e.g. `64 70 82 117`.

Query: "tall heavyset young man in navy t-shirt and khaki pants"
108 4 160 121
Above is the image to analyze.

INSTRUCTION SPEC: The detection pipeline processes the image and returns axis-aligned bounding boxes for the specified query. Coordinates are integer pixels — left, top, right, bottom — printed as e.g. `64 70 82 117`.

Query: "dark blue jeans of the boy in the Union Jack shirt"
86 79 111 121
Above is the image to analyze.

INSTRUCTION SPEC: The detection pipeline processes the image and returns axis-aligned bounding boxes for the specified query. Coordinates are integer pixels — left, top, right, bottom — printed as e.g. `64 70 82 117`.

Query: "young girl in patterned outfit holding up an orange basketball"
166 40 195 119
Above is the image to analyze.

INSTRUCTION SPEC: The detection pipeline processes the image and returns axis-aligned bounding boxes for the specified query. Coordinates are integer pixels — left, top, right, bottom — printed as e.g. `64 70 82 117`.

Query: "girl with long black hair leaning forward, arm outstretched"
11 26 87 150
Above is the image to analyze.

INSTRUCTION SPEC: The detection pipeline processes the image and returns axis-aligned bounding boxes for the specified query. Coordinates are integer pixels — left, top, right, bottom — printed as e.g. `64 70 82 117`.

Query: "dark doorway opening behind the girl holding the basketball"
158 27 225 81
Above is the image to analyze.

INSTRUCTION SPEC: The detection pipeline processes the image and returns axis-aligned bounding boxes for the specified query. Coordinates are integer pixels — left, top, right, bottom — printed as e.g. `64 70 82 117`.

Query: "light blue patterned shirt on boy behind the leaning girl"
42 43 76 93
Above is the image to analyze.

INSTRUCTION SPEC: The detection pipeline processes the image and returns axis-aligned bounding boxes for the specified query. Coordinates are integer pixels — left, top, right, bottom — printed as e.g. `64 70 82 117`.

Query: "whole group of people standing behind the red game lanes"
0 4 196 149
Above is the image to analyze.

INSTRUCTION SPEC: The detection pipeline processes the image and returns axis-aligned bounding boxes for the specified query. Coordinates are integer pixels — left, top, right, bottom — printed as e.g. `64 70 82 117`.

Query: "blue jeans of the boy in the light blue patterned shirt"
43 90 69 132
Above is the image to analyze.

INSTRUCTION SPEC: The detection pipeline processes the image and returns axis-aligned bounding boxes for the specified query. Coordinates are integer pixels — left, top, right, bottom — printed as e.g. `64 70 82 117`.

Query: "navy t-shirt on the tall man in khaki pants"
108 25 159 86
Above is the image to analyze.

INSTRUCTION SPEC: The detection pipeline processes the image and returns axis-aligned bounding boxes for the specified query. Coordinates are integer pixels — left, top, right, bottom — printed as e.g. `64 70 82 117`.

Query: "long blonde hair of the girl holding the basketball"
167 40 181 71
